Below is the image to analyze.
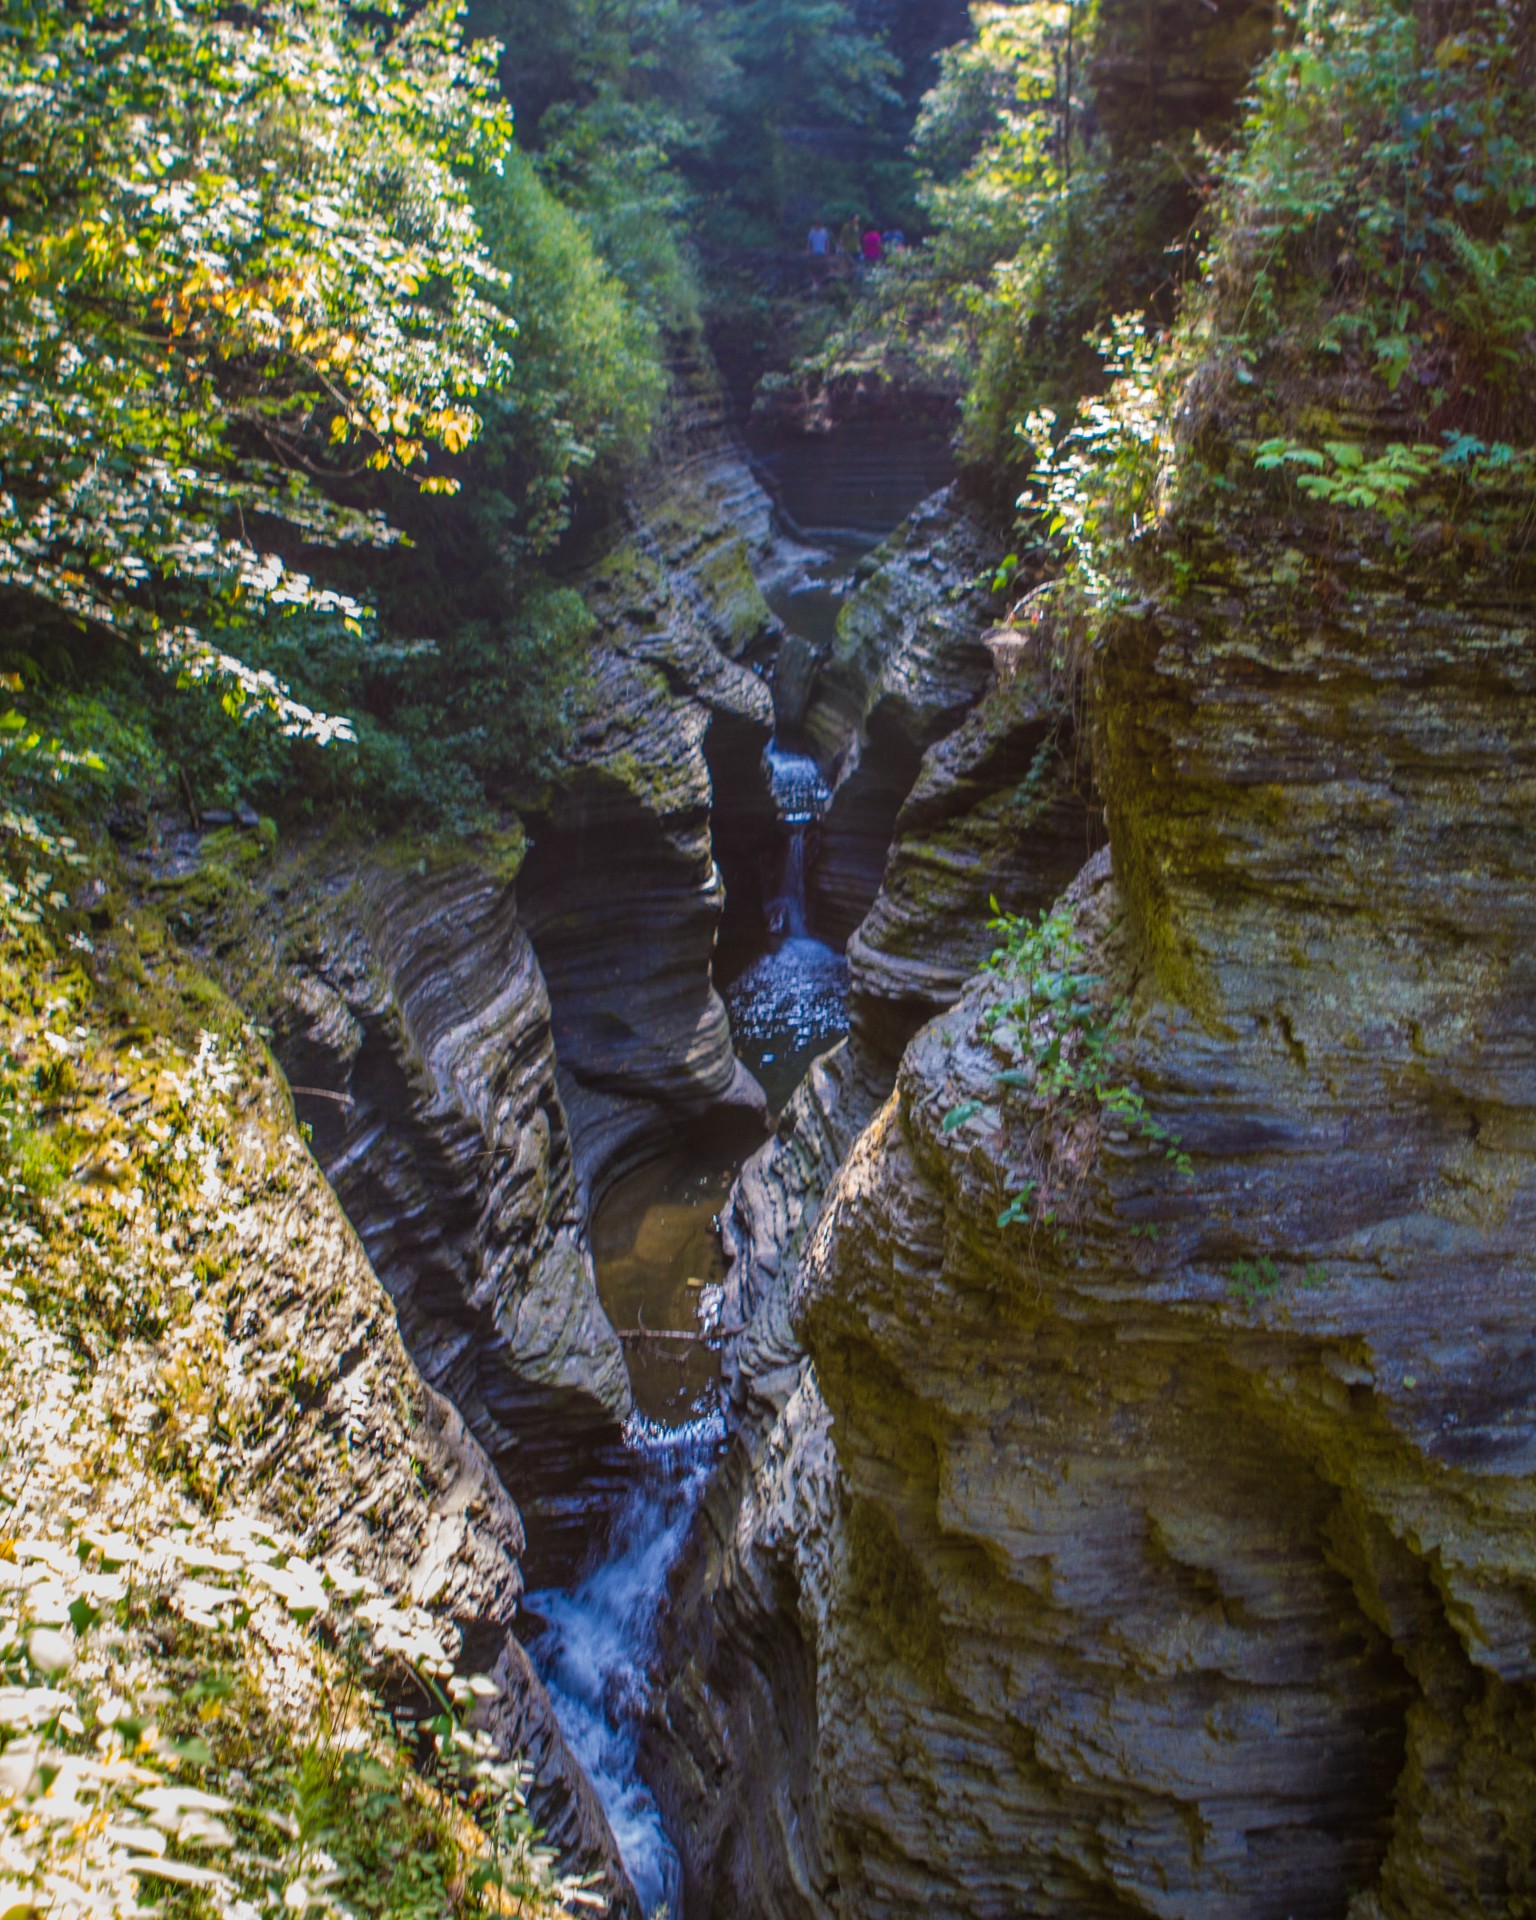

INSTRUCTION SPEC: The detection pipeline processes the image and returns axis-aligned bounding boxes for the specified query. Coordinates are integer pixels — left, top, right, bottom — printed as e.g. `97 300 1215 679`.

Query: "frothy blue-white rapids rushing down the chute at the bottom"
528 1451 714 1920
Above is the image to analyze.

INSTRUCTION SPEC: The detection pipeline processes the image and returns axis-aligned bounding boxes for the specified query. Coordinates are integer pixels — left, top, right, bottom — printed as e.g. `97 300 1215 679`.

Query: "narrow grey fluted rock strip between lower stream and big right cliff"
643 1044 879 1920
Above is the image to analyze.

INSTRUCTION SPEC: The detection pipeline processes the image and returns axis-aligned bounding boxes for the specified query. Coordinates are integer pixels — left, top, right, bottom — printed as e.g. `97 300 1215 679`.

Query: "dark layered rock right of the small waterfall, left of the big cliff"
849 660 1102 1068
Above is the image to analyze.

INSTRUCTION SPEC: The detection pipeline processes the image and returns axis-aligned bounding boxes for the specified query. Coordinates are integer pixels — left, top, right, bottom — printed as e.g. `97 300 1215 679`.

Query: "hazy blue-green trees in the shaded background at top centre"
480 0 914 268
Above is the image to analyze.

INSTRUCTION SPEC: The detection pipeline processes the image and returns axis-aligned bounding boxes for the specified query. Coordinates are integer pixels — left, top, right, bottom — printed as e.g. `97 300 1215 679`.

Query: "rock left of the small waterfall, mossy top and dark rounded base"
522 353 778 1194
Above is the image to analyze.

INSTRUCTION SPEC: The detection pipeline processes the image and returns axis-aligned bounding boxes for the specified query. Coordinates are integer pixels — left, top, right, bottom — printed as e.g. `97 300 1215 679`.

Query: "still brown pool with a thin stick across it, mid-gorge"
591 1154 735 1427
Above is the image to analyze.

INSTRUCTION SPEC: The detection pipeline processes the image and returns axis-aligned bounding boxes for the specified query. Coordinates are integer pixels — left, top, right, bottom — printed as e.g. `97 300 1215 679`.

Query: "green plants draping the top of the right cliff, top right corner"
1212 0 1536 440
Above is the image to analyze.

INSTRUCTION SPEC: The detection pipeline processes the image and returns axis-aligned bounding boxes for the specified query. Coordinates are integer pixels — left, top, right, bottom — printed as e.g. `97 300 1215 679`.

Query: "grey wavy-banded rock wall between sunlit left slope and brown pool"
188 833 630 1571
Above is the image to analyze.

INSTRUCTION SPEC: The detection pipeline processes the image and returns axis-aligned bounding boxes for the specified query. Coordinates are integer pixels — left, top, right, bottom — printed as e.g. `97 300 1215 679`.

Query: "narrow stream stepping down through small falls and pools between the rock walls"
526 468 937 1920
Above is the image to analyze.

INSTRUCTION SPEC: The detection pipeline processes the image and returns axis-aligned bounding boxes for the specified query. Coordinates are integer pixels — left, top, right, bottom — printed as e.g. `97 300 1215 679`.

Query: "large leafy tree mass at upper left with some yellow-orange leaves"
0 0 691 826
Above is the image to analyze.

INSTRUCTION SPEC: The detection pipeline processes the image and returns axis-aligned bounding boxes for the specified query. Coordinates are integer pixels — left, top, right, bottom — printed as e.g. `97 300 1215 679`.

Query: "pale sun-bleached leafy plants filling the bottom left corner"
0 1482 580 1920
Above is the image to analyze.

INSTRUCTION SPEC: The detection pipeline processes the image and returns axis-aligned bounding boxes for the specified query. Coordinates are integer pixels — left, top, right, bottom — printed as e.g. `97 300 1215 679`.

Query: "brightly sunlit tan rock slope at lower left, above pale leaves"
200 1052 639 1920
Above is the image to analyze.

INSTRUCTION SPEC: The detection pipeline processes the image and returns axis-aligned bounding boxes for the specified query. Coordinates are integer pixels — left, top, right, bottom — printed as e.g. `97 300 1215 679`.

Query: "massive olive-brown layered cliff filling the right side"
659 382 1536 1920
